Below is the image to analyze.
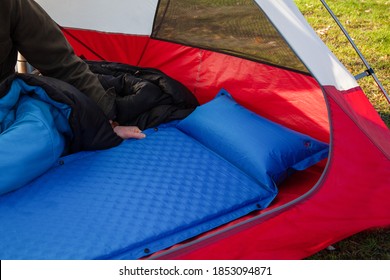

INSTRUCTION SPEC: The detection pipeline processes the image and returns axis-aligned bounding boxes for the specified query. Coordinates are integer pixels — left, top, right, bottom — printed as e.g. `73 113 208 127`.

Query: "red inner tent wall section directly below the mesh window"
140 40 329 142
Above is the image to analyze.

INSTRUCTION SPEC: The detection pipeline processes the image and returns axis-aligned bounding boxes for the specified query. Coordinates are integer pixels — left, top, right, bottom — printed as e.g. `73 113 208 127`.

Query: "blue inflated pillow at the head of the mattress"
177 91 329 189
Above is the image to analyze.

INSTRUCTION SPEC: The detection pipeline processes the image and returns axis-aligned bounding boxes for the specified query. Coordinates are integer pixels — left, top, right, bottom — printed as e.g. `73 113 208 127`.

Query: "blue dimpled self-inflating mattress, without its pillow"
0 124 276 259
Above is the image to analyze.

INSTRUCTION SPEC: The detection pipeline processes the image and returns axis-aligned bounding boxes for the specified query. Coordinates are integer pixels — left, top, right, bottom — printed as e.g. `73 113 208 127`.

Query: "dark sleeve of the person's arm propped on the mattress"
11 0 115 118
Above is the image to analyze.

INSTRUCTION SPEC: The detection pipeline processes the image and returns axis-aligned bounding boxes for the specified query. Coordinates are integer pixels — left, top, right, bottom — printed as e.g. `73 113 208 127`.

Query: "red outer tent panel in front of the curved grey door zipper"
154 88 390 259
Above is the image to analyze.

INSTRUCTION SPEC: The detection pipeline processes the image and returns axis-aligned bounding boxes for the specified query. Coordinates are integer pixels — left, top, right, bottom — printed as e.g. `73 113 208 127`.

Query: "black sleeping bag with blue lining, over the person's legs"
0 71 122 196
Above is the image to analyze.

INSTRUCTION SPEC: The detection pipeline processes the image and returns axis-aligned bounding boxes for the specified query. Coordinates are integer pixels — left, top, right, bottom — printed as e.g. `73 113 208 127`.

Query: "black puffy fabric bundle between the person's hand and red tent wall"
87 61 199 130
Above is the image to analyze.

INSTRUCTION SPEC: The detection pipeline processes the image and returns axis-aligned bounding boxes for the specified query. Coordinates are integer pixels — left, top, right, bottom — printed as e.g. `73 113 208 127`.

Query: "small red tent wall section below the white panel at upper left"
63 28 149 65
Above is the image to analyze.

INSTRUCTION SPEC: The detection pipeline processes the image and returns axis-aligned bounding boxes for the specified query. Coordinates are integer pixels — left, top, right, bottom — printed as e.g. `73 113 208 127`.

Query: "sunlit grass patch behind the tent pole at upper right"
295 0 390 126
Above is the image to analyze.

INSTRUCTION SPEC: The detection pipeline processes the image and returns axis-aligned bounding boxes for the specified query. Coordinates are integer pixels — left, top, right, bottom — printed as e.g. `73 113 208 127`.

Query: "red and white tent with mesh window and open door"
3 0 390 259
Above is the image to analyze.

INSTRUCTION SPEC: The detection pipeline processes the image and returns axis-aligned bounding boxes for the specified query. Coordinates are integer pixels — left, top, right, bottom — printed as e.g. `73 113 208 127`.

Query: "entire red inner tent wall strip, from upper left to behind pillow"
64 28 329 142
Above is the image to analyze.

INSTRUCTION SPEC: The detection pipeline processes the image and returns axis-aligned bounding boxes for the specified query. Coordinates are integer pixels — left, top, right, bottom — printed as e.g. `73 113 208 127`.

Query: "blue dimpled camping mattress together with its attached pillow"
0 88 328 259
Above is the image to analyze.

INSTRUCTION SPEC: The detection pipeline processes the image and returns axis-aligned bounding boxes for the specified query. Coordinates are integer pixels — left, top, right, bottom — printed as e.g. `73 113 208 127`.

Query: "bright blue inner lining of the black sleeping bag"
0 79 72 195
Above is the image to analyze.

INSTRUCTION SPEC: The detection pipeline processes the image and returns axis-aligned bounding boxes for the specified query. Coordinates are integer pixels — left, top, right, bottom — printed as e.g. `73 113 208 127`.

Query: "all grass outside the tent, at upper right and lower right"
295 0 390 260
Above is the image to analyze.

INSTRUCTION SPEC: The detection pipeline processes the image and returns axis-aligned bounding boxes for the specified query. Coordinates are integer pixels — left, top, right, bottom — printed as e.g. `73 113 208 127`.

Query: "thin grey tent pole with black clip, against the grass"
320 0 390 103
